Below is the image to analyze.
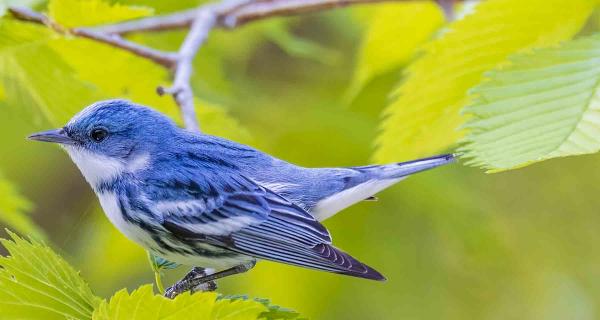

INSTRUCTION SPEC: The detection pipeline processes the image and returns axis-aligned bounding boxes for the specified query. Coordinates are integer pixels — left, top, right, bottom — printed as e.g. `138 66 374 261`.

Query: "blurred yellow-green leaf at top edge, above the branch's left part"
48 0 154 27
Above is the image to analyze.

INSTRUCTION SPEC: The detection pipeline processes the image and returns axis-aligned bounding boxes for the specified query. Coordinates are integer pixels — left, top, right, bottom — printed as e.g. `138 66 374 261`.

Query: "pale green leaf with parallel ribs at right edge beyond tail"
461 35 600 171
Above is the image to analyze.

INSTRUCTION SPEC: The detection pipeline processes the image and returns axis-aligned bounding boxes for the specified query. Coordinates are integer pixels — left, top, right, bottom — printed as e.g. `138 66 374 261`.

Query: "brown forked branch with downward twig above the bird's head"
9 0 453 131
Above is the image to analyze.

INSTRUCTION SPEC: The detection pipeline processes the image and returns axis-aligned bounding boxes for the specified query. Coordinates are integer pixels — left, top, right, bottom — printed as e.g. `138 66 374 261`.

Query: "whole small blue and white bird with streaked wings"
28 99 455 297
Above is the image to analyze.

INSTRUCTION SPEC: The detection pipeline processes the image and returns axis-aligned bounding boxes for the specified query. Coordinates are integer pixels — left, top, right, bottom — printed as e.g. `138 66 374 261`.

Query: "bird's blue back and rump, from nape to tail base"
143 130 373 210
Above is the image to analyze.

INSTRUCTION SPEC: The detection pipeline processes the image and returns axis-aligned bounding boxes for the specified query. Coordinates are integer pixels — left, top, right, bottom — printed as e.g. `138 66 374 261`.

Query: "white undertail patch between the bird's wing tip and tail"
310 178 404 221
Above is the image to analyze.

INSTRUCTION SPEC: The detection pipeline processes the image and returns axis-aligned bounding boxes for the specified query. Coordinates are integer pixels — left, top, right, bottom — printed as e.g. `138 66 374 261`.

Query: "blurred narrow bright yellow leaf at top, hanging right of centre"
346 1 445 101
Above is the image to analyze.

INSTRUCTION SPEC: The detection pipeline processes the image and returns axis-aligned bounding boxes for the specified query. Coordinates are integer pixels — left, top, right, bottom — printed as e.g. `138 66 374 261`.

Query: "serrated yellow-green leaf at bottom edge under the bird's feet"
92 285 266 320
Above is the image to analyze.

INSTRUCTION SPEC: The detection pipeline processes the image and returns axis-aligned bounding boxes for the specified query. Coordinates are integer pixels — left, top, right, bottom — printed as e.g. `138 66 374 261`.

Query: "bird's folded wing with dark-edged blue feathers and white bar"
157 173 384 280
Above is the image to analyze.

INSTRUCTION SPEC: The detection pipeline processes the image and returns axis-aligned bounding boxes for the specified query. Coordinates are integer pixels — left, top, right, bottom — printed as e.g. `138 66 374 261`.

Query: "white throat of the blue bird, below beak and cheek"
64 146 150 187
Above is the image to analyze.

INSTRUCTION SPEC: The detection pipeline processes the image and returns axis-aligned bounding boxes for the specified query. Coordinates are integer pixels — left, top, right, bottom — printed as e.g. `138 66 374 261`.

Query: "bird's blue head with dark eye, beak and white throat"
29 100 179 186
